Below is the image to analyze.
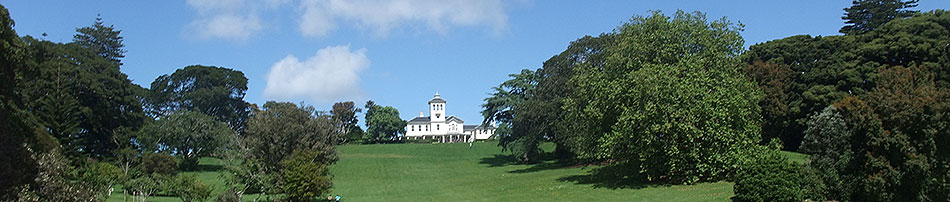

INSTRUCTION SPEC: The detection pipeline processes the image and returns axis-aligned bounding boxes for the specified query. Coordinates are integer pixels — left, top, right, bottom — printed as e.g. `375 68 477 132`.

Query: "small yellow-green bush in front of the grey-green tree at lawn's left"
281 150 331 201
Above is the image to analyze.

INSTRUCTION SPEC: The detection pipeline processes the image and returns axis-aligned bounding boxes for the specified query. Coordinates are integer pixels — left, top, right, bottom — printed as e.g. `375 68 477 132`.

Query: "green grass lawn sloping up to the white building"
108 142 807 201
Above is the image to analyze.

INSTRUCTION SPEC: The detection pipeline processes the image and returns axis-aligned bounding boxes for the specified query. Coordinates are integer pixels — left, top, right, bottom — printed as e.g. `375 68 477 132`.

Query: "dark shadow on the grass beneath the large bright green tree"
558 165 669 189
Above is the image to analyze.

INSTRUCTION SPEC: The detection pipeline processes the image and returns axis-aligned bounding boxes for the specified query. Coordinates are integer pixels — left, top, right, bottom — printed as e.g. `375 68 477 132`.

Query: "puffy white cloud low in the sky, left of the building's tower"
264 45 370 102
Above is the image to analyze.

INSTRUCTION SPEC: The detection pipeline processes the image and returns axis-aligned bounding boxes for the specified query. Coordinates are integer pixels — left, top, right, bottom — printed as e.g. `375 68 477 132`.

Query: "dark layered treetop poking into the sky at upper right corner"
838 0 919 35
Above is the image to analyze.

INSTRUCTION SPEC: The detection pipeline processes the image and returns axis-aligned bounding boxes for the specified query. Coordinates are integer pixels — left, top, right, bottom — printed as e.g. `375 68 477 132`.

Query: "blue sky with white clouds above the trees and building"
0 0 950 124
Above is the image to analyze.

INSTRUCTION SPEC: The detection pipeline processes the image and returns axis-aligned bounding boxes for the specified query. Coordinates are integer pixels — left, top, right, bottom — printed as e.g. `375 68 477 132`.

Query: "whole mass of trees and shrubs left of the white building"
0 5 405 201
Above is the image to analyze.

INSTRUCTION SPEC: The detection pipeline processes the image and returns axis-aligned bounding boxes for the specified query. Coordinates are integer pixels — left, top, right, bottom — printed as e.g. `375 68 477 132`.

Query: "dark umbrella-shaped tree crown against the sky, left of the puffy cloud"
146 65 250 132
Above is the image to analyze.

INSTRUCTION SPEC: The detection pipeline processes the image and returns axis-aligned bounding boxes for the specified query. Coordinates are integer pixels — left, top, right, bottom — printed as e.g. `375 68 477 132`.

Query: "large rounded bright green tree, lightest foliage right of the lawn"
564 11 761 183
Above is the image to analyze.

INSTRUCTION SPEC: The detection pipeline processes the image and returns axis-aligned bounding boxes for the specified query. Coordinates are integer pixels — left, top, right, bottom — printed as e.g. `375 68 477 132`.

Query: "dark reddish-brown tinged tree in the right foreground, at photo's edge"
802 67 950 201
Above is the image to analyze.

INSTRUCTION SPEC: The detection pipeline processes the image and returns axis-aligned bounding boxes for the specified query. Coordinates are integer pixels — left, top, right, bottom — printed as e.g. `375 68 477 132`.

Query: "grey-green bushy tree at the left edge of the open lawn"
242 101 338 193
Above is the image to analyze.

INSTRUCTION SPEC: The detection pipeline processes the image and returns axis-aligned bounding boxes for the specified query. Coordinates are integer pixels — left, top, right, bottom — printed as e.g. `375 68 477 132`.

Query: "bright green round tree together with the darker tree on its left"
483 11 761 183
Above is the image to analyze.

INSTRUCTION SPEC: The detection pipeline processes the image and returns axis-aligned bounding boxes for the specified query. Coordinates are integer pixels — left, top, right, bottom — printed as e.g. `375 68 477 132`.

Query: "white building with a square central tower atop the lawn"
401 93 495 142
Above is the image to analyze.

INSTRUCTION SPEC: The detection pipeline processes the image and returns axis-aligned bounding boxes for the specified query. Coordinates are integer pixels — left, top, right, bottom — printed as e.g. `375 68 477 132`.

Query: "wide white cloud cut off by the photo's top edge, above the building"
300 0 508 37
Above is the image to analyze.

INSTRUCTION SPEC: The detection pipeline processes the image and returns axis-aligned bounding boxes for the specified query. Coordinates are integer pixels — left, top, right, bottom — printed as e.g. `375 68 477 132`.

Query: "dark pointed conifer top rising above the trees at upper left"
73 15 126 65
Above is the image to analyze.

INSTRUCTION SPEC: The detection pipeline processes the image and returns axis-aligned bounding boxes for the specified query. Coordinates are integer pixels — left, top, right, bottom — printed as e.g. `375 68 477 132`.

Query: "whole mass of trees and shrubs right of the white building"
482 0 950 201
